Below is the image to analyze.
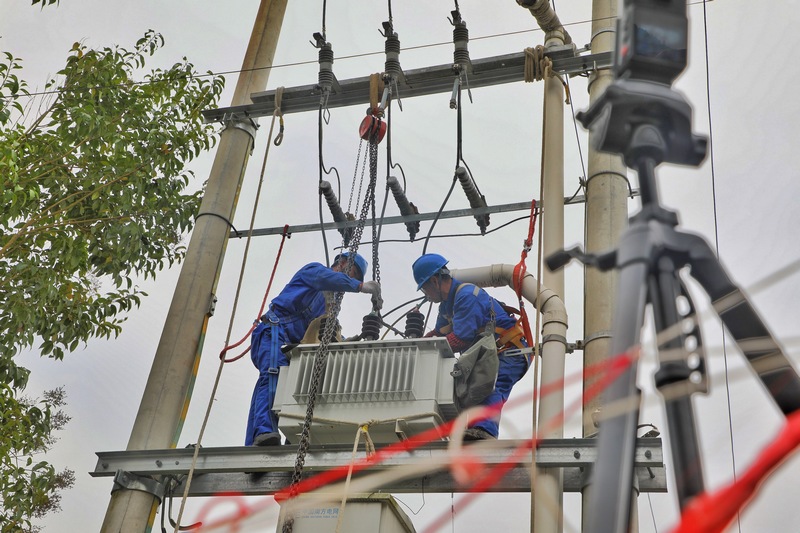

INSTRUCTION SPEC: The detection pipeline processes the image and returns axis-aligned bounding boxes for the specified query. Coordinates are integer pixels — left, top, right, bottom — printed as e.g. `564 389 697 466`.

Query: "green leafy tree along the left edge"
0 29 224 531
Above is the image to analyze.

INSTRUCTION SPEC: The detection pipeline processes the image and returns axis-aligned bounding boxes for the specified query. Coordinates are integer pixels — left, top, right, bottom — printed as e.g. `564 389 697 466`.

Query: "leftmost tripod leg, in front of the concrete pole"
588 262 648 533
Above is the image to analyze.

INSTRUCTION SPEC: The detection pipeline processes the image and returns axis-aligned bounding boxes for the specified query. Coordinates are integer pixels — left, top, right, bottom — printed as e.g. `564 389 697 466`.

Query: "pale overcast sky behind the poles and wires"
0 0 800 533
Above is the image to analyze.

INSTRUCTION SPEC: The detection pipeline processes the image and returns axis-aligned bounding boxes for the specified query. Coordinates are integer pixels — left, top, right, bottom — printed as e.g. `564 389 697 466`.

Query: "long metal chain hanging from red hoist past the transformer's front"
282 132 378 533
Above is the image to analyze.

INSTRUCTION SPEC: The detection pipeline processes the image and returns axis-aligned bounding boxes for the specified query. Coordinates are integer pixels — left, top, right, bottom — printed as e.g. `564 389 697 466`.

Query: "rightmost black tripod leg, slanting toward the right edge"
689 236 800 415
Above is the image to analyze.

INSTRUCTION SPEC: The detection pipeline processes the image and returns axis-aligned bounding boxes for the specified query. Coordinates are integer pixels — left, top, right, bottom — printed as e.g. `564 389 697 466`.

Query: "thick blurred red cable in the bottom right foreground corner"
673 411 800 533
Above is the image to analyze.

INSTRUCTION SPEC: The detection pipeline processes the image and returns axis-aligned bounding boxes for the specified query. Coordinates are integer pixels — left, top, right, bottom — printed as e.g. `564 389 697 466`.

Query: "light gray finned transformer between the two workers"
274 338 458 445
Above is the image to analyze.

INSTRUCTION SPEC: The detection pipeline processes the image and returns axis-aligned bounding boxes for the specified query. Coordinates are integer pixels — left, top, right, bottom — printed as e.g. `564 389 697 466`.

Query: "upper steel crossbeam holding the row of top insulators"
203 46 613 122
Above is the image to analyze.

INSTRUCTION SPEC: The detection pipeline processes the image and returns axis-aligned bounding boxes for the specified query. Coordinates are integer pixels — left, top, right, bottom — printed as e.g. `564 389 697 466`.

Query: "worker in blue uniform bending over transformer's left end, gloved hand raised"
245 252 383 446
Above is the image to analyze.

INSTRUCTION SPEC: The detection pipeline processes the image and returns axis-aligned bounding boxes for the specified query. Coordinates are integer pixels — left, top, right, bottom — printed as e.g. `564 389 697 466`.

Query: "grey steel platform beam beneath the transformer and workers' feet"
90 438 667 496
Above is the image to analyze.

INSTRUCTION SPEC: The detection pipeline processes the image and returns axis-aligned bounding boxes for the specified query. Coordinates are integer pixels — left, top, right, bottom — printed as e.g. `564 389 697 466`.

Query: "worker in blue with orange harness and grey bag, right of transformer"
412 254 529 441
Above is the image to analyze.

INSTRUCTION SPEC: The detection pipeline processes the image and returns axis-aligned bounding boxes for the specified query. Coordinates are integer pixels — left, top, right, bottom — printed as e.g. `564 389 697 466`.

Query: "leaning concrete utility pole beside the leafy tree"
102 0 287 533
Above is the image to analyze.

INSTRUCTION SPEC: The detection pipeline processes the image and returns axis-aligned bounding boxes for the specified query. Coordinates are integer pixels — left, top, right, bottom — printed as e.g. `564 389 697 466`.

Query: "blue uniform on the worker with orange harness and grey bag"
436 279 528 437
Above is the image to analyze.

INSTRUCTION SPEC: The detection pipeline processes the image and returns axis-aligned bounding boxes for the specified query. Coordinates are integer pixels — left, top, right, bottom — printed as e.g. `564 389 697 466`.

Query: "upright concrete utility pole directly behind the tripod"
583 0 636 530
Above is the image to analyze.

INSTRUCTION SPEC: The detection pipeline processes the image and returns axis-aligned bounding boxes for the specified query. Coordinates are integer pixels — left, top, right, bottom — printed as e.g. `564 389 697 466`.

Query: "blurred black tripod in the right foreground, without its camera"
546 79 800 533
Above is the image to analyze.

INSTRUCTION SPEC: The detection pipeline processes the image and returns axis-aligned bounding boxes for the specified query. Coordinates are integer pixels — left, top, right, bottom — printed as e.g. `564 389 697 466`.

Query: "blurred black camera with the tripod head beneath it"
577 0 706 168
